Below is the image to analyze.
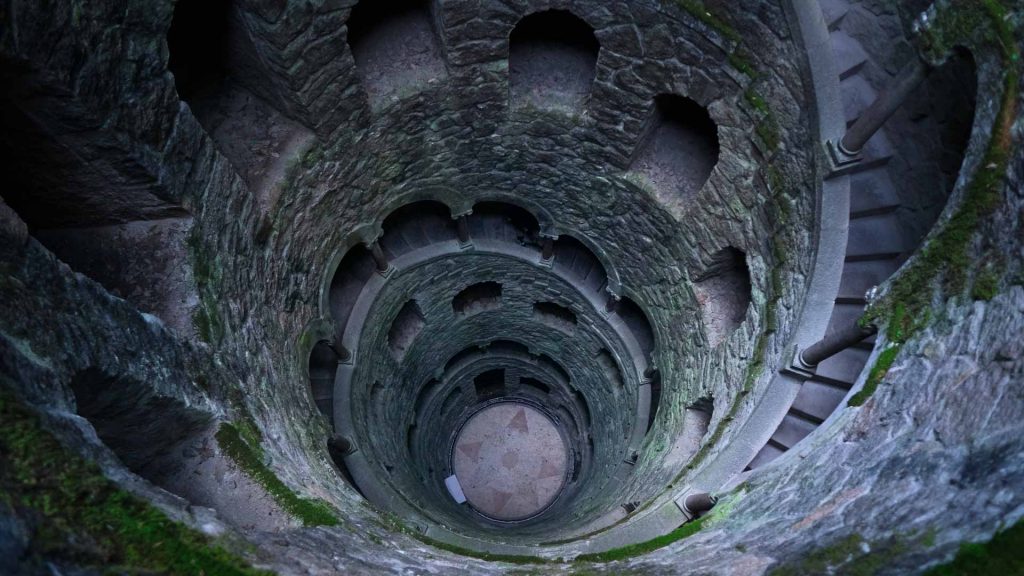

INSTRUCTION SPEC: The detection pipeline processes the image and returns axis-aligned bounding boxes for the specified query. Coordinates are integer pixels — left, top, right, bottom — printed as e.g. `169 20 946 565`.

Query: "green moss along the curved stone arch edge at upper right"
867 0 1020 336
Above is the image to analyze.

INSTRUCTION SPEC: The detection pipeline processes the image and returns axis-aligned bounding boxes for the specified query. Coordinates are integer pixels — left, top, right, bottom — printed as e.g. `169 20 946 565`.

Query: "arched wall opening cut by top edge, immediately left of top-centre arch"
347 0 447 110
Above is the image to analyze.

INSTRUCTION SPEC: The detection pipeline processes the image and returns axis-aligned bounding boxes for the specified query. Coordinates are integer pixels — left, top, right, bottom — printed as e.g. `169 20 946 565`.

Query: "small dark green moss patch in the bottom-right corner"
925 522 1024 576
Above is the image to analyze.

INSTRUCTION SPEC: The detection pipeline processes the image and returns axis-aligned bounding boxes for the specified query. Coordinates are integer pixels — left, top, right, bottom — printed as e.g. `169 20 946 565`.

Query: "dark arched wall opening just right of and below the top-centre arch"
630 94 719 204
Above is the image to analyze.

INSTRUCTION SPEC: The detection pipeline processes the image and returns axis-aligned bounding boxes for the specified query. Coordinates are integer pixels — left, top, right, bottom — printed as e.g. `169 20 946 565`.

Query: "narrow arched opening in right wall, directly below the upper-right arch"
693 246 751 346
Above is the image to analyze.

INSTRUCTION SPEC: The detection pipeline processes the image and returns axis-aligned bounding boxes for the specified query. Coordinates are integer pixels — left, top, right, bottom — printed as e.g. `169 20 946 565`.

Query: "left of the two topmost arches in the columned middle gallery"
380 200 456 258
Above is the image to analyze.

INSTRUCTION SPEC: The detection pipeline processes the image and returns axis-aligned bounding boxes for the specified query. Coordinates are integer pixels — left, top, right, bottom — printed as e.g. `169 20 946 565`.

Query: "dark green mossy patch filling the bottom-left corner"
0 390 267 576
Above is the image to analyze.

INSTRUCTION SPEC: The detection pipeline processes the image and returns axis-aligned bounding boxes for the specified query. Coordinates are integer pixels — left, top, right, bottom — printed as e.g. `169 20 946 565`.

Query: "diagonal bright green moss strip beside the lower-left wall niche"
216 422 338 526
